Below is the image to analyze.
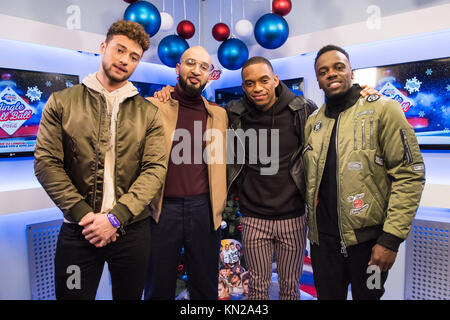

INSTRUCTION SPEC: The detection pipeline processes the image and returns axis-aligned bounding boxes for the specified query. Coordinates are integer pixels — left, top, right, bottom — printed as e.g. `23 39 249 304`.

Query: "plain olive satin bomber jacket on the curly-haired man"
34 84 167 226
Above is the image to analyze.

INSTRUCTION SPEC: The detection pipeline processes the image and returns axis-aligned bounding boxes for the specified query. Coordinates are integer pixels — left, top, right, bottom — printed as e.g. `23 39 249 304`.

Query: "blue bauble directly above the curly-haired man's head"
123 1 161 37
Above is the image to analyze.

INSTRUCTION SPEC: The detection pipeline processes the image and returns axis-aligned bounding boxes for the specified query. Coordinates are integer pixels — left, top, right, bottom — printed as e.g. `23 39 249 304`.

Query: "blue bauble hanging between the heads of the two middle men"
217 38 248 70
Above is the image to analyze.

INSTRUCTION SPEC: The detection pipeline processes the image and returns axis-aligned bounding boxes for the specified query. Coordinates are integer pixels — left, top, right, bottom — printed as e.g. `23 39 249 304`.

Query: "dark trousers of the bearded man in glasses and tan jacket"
144 194 220 300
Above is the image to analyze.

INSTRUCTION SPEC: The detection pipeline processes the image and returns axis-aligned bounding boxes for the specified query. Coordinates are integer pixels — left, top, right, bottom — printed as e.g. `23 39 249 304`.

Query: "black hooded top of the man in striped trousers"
239 82 305 219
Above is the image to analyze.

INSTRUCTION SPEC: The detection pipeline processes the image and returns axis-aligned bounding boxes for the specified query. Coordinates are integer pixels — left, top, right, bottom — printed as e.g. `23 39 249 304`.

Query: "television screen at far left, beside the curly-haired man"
0 68 79 157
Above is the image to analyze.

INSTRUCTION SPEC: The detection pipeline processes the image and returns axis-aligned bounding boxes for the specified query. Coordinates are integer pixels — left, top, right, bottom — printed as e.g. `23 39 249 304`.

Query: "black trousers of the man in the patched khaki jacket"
311 234 388 300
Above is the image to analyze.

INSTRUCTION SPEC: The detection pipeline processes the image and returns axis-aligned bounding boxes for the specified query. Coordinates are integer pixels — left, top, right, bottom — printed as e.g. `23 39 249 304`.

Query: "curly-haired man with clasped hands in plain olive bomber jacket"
34 20 167 300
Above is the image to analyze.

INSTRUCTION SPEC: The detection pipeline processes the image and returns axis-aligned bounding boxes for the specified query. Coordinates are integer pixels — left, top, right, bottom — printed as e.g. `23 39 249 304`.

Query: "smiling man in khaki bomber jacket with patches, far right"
303 45 425 299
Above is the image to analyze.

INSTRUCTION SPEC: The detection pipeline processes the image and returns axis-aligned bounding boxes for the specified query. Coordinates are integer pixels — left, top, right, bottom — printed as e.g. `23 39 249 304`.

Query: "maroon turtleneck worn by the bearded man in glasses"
164 84 209 198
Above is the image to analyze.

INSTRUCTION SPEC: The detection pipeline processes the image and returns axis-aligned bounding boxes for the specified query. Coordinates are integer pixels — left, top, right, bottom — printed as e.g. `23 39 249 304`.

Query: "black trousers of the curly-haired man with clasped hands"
55 218 150 300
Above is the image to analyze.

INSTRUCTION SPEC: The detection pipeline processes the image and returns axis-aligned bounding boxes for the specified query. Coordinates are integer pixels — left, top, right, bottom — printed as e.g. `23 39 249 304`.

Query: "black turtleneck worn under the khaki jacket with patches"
317 84 362 238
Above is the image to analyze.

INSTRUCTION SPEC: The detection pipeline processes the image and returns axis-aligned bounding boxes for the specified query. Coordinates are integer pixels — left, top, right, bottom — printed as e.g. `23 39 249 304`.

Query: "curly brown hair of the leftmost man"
106 19 150 52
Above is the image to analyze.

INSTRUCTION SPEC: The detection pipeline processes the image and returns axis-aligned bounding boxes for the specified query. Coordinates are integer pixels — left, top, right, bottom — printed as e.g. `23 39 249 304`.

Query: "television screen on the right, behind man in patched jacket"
354 58 450 149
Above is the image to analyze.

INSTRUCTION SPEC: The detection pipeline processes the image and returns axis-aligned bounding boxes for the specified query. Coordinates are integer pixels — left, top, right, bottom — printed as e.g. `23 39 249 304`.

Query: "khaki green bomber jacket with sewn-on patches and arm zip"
303 95 425 246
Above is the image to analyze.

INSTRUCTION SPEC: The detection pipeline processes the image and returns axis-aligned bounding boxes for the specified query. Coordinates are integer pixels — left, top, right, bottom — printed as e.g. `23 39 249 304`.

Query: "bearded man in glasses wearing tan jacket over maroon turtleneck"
145 46 228 300
